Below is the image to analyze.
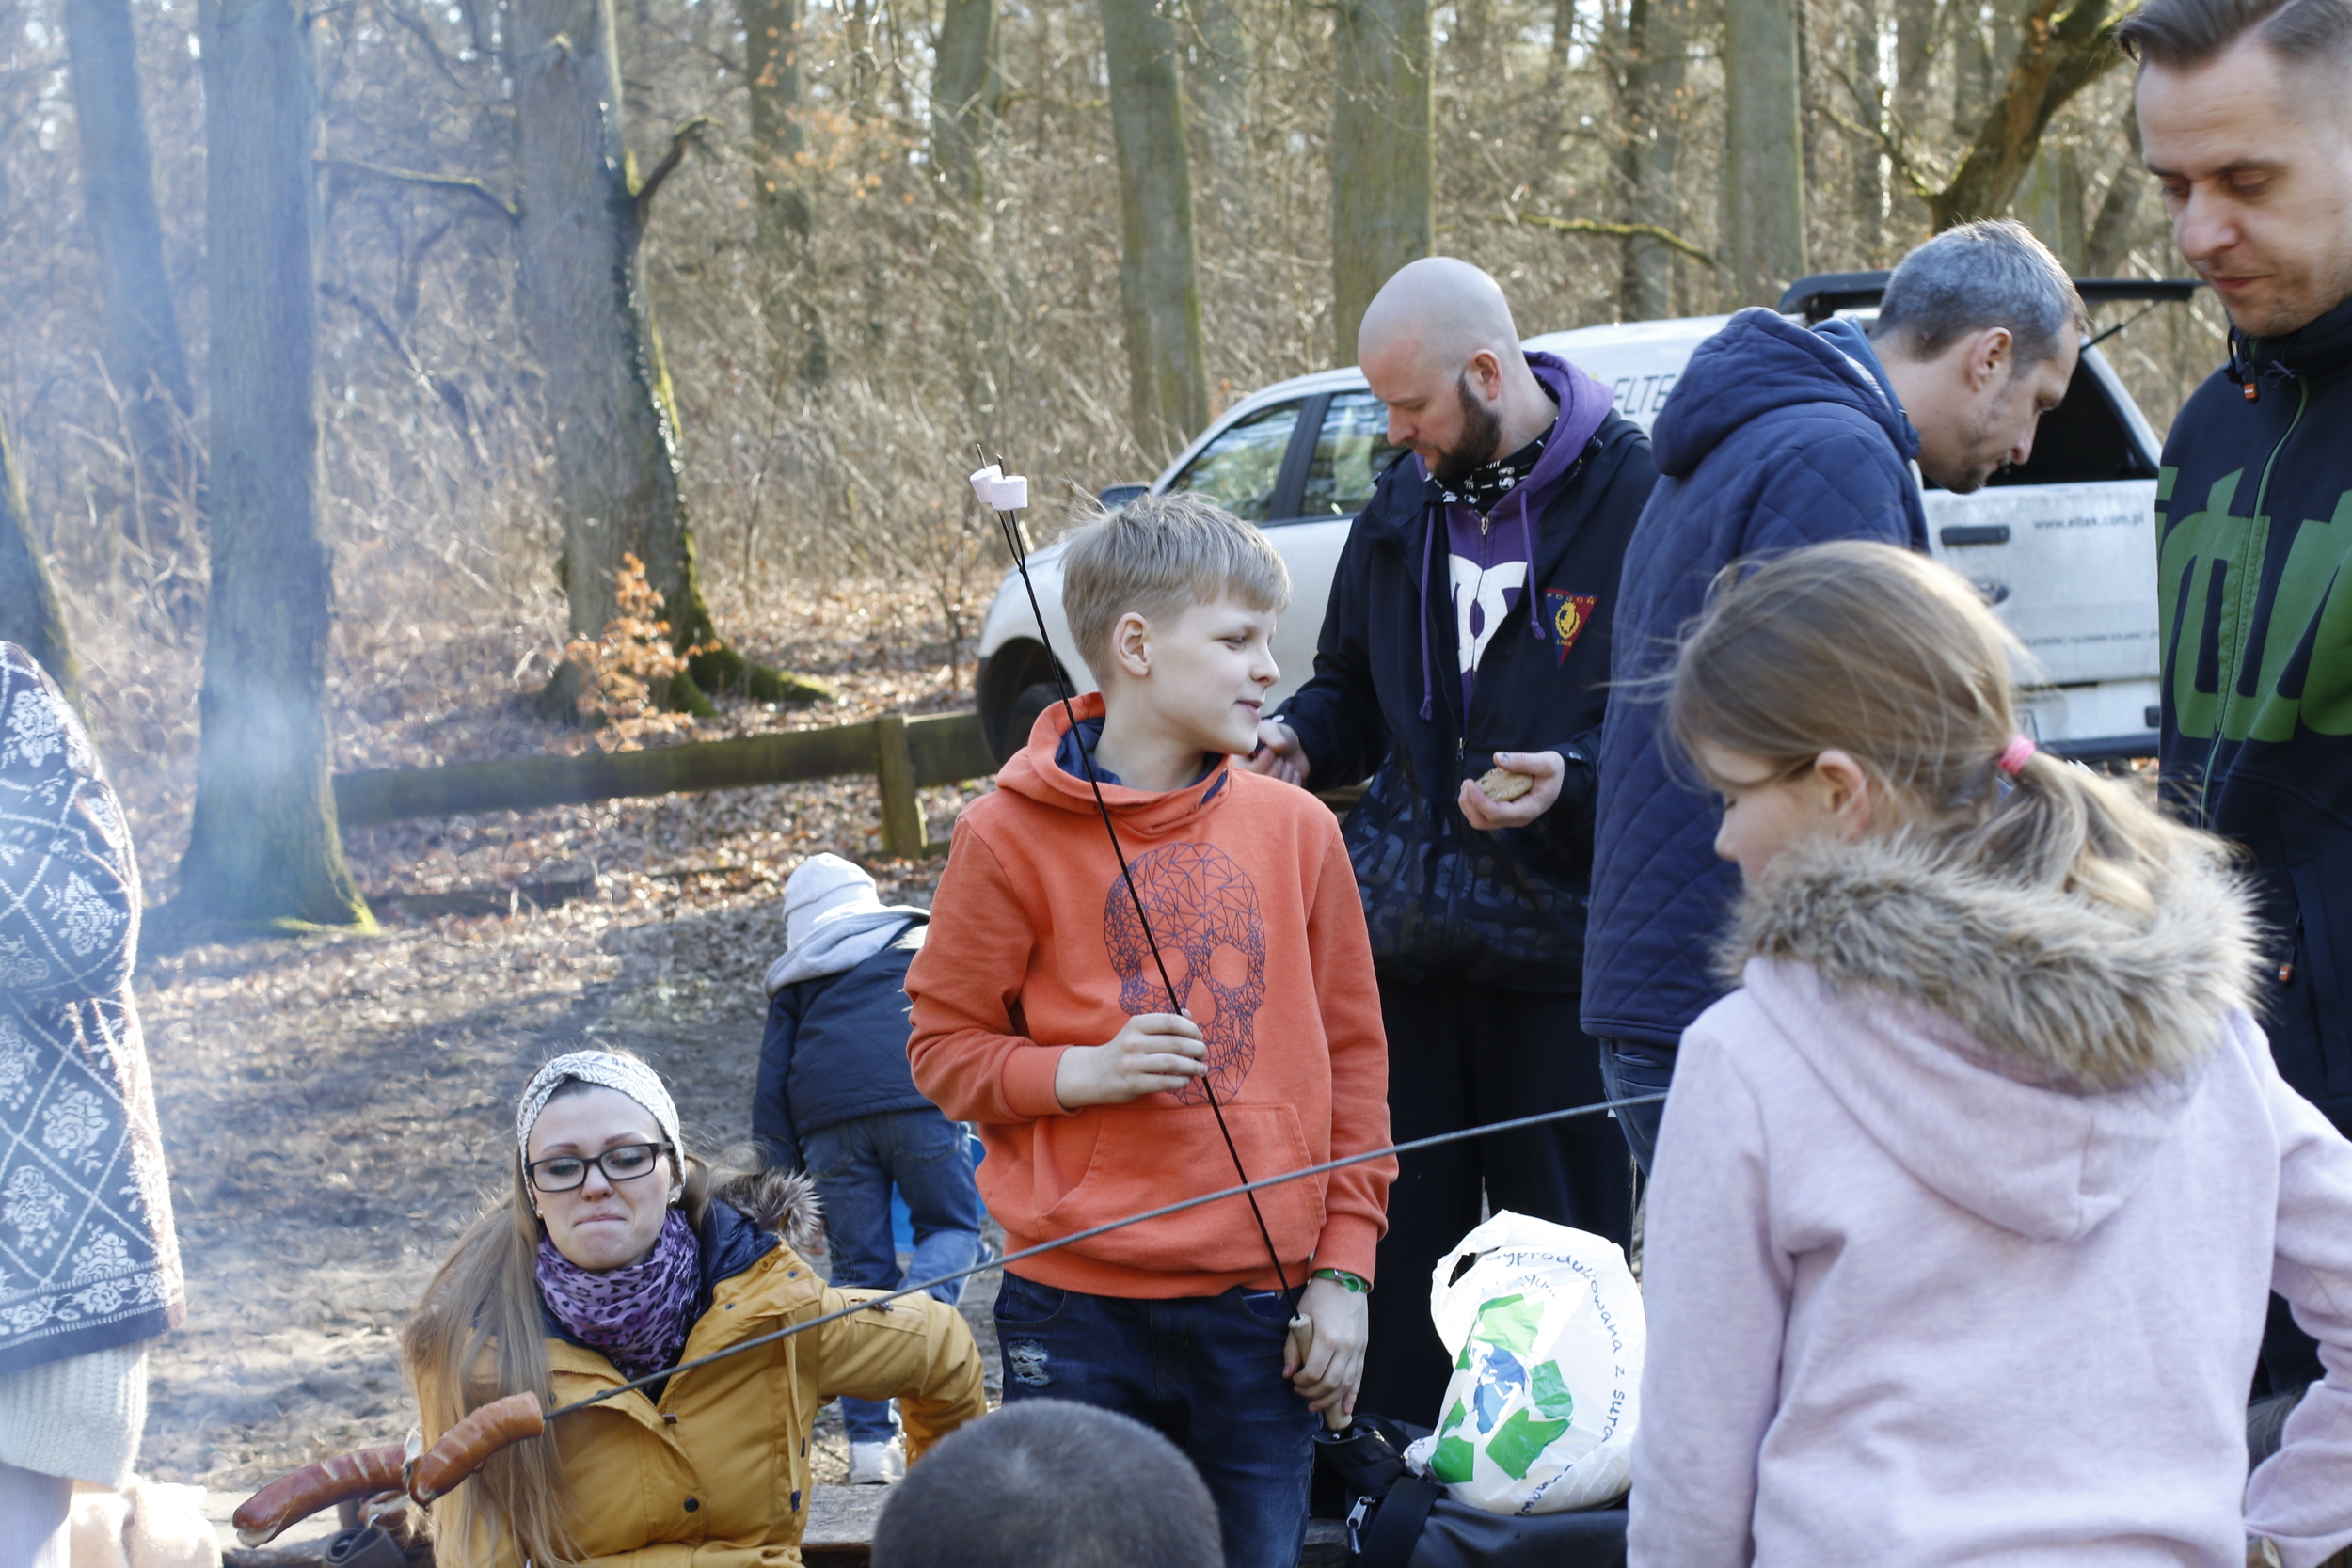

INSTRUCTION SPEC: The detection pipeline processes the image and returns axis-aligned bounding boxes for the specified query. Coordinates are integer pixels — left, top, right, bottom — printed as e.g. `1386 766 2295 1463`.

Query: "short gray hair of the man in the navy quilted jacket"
1870 218 2091 364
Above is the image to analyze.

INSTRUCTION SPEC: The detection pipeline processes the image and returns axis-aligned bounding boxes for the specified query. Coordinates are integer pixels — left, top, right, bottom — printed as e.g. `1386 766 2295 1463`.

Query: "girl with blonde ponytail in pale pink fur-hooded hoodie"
1630 543 2352 1568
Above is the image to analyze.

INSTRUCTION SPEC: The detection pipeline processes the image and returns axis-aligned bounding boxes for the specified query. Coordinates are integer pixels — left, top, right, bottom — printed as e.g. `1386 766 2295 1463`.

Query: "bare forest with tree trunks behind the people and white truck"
0 0 2218 924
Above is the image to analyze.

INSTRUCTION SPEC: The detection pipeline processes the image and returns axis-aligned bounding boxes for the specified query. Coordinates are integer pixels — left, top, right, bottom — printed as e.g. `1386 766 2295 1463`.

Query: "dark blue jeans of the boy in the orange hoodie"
997 1275 1320 1568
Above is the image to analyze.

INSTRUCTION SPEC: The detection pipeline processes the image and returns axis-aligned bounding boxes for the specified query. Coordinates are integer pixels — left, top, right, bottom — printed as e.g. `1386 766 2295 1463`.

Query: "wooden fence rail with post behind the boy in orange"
334 712 997 856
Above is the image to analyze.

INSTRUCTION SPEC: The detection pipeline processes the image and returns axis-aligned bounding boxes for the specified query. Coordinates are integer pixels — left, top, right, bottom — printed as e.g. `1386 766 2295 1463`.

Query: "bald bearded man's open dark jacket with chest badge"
1279 369 1659 994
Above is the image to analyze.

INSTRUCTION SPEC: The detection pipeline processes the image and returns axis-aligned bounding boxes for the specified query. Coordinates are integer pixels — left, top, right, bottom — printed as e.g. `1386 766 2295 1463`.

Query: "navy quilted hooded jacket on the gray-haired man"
1583 310 1927 1049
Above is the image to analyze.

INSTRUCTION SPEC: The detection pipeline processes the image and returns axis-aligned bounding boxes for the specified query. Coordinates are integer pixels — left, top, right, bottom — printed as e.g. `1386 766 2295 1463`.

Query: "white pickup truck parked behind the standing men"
977 273 2195 775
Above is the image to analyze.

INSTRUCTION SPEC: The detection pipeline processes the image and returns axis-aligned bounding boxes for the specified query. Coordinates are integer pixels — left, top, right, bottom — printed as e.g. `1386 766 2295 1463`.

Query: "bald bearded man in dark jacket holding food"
1251 256 1659 1422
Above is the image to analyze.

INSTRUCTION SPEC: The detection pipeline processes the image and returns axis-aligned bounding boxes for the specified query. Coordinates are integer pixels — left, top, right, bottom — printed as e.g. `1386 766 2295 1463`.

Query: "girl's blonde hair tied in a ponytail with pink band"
1668 541 2223 914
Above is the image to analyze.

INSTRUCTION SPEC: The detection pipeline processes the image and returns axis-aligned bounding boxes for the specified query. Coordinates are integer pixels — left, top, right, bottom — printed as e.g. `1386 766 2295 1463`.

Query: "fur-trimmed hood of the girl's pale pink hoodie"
1722 839 2256 1242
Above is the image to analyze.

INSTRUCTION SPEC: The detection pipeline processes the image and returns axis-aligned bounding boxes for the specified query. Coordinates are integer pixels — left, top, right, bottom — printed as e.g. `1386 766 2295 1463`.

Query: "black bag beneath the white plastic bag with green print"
1315 1416 1626 1568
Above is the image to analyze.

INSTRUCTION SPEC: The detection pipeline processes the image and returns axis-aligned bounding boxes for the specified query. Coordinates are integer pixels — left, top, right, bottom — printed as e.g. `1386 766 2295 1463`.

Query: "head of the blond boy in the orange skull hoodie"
1061 491 1292 752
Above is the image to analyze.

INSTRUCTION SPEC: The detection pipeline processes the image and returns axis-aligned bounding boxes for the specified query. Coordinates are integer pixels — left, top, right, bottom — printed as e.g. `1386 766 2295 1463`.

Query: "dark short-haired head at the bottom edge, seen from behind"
873 1399 1226 1568
